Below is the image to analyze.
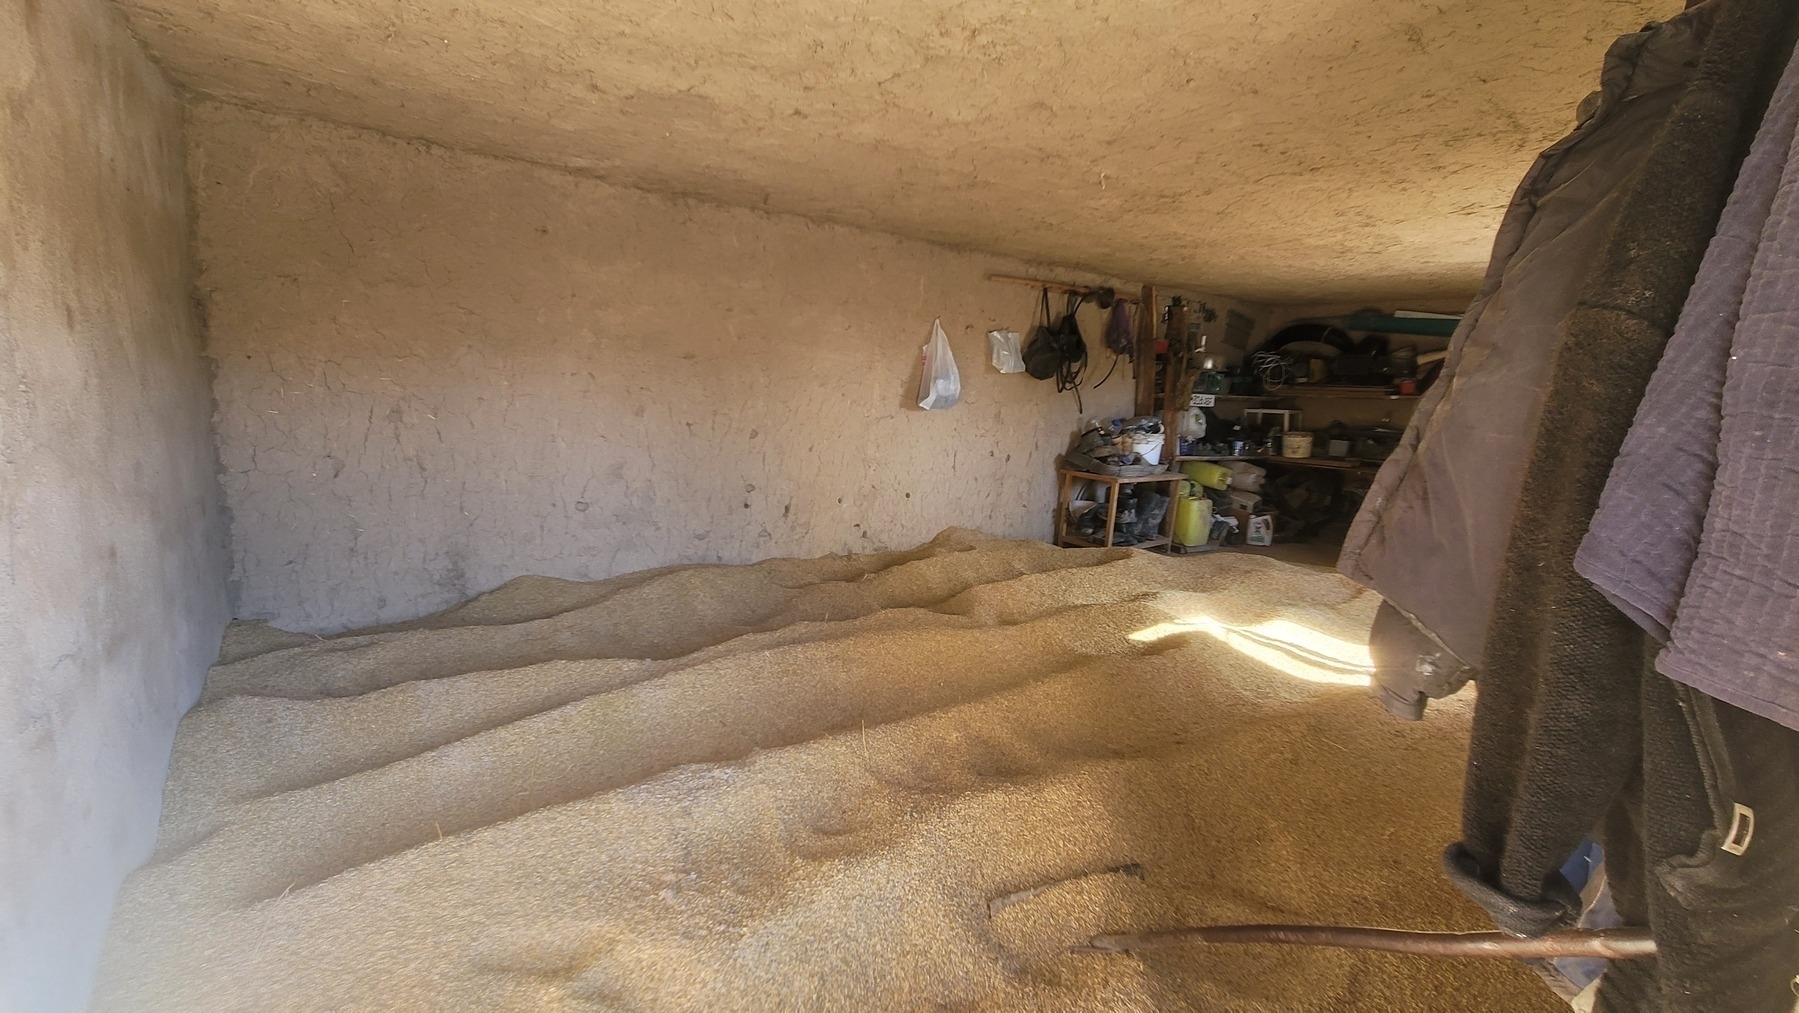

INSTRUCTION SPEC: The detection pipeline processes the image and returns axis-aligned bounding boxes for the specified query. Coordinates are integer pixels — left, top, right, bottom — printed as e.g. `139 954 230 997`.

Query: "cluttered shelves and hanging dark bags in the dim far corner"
1014 275 1455 552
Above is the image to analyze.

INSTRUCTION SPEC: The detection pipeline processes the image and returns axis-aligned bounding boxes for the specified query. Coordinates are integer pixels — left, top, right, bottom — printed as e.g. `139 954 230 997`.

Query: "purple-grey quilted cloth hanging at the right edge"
1576 39 1799 729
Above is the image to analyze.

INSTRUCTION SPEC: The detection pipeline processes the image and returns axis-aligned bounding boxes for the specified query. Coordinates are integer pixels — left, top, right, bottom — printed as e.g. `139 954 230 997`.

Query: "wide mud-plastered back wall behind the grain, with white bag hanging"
189 103 1259 632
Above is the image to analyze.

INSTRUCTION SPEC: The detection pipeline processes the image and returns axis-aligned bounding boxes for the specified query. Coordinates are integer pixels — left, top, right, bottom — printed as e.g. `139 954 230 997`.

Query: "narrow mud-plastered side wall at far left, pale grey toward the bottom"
0 0 227 1011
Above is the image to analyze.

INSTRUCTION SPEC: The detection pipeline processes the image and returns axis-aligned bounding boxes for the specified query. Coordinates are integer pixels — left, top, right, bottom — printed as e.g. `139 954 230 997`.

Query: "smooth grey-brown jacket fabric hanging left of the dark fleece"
1338 7 1713 698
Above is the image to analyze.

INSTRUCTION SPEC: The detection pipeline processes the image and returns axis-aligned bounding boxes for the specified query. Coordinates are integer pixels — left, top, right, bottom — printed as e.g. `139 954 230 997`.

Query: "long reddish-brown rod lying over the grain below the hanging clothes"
1072 925 1655 961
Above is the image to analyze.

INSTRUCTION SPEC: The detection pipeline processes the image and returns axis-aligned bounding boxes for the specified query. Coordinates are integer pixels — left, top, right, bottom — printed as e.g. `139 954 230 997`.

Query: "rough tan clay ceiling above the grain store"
122 0 1680 302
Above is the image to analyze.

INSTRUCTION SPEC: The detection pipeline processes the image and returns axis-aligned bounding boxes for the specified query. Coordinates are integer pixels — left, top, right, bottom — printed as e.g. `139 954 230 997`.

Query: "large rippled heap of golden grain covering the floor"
95 531 1558 1013
